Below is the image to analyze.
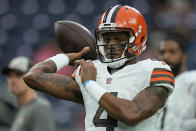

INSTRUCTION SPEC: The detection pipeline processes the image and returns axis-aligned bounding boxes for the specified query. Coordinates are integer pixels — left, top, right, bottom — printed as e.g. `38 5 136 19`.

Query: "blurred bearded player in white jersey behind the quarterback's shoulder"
157 36 196 131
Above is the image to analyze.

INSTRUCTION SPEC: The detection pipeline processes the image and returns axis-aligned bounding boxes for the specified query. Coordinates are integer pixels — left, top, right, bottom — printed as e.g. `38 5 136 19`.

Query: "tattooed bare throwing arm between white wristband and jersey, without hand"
23 61 83 104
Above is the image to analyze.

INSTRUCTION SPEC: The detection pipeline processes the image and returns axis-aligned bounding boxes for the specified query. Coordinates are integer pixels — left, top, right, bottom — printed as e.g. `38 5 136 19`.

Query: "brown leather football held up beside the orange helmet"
54 21 97 60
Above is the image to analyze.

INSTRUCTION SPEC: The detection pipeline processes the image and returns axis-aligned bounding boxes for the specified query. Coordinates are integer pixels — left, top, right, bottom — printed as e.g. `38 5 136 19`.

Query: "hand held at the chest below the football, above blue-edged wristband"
76 59 97 84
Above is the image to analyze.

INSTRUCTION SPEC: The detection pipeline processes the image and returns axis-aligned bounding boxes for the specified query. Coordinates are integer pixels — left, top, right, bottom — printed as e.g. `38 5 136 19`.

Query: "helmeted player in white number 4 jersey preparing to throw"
24 5 174 131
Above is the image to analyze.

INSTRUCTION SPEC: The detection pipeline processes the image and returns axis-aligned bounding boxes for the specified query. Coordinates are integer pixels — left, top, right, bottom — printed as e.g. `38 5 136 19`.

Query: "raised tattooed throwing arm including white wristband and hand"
24 47 89 103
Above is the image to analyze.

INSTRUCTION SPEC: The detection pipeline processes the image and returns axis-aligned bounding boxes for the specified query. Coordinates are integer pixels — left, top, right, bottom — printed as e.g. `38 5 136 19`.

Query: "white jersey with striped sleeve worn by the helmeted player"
75 59 174 131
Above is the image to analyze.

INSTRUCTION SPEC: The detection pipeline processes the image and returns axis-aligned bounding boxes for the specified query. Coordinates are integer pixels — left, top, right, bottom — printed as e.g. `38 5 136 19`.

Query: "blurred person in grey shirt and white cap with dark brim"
2 56 55 131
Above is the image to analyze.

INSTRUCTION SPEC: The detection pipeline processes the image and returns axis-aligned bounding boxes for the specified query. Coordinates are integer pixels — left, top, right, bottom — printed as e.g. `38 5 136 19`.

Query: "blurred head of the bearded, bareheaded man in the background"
158 36 187 76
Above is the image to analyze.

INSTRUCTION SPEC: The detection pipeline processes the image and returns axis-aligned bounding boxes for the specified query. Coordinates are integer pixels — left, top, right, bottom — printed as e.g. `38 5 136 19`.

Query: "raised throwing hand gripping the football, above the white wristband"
66 47 90 65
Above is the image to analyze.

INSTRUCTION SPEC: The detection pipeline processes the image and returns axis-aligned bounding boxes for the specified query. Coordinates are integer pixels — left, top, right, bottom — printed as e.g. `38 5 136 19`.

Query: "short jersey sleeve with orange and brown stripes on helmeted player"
150 62 175 92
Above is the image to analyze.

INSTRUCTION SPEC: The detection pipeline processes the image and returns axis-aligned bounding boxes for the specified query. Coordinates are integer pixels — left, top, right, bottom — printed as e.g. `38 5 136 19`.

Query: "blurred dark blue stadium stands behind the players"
0 0 196 131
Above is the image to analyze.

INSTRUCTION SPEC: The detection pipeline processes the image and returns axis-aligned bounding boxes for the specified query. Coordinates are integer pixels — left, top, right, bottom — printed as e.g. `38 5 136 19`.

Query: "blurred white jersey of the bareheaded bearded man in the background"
156 71 196 131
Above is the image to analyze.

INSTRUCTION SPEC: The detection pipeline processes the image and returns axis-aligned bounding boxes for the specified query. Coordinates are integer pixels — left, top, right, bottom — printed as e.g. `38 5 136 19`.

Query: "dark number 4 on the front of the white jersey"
93 92 118 131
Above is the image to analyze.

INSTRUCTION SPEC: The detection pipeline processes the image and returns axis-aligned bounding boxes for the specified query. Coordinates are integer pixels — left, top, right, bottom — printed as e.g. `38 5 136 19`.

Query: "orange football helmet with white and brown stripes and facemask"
95 5 147 68
